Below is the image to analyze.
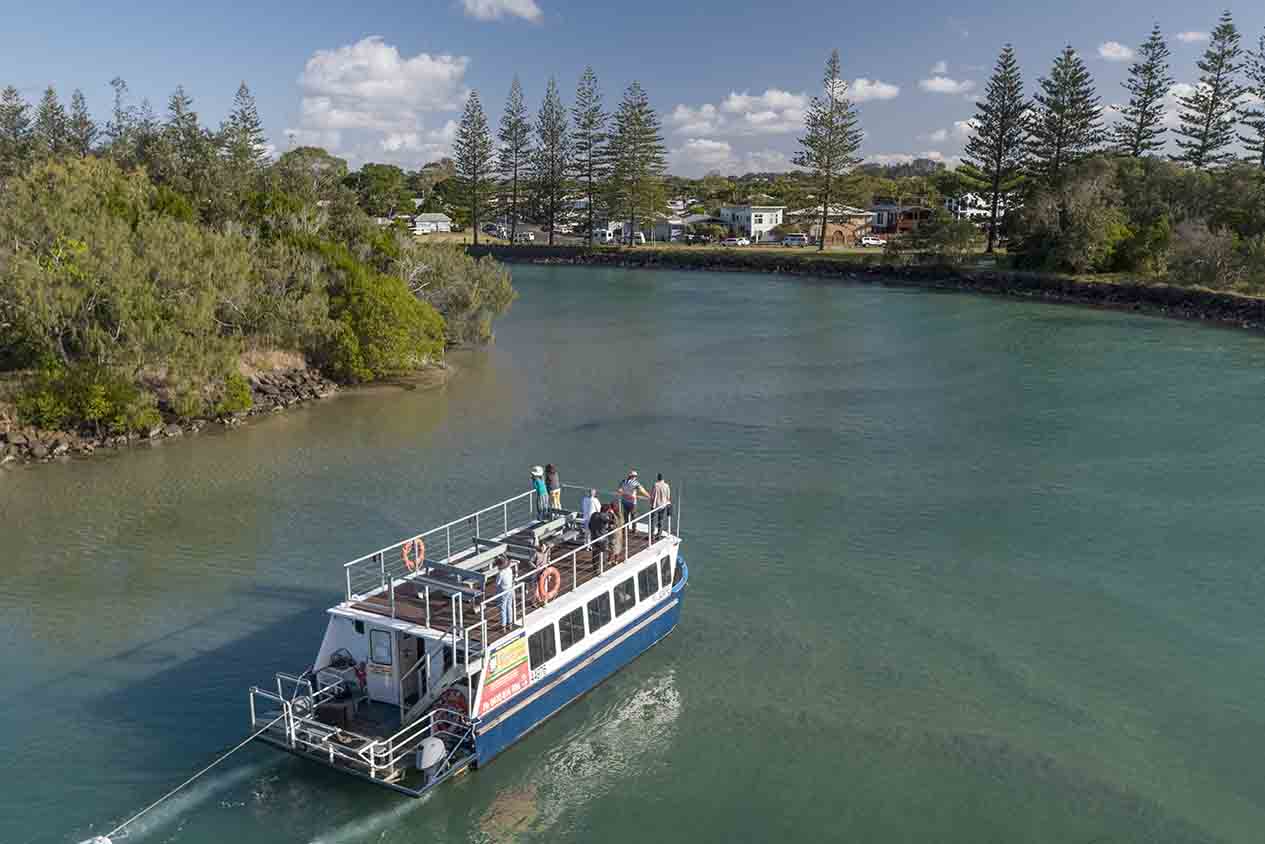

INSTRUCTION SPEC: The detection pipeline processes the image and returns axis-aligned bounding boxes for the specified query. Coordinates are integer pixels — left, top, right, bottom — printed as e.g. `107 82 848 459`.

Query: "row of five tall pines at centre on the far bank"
453 67 667 244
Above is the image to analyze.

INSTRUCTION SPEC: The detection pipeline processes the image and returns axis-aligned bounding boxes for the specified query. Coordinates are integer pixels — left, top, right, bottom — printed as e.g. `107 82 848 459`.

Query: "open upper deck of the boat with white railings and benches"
335 486 672 652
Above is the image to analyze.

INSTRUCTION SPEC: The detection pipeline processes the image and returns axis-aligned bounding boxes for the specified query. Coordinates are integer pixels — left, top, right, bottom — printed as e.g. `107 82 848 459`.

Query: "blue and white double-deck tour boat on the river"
249 485 688 797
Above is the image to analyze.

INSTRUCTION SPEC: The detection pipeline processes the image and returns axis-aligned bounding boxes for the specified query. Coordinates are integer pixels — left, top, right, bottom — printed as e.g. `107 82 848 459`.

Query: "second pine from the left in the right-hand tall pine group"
1027 44 1103 185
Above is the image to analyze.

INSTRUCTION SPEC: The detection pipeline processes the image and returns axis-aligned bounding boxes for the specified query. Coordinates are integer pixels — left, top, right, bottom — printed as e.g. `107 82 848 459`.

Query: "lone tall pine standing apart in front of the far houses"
793 49 861 252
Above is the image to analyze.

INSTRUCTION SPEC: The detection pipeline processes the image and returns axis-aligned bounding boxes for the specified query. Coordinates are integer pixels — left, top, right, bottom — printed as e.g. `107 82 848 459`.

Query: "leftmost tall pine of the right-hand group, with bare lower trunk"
964 44 1028 252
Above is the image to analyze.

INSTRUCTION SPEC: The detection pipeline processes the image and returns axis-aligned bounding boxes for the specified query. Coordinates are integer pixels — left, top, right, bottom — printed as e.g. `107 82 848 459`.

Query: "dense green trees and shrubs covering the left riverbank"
0 78 514 431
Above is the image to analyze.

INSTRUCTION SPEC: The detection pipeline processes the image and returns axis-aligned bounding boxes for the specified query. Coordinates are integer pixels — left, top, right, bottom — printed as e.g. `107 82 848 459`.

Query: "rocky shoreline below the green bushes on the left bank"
0 369 338 466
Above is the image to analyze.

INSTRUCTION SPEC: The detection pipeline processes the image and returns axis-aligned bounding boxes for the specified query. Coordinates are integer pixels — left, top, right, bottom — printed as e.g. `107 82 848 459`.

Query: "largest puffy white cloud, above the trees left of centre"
287 35 469 164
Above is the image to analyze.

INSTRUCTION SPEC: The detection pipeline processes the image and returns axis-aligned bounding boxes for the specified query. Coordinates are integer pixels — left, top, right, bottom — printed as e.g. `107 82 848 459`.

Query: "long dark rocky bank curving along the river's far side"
468 245 1265 330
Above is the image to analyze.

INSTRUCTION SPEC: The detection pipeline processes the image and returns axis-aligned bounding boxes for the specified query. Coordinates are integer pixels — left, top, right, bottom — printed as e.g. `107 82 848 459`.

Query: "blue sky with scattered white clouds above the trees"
0 0 1265 176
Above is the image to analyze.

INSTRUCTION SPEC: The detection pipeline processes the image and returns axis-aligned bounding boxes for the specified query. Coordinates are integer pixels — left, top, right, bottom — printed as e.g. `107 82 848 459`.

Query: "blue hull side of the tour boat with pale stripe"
476 559 689 766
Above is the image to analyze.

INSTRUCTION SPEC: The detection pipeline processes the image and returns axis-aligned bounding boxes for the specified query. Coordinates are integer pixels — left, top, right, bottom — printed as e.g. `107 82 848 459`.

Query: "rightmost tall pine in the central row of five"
611 82 668 244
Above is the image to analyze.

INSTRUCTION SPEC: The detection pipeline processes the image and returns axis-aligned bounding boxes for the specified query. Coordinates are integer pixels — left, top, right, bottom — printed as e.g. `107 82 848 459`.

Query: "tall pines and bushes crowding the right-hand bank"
950 11 1265 287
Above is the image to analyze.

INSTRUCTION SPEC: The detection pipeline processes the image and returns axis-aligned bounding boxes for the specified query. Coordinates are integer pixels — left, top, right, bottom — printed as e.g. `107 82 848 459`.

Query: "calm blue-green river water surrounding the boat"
0 267 1265 844
